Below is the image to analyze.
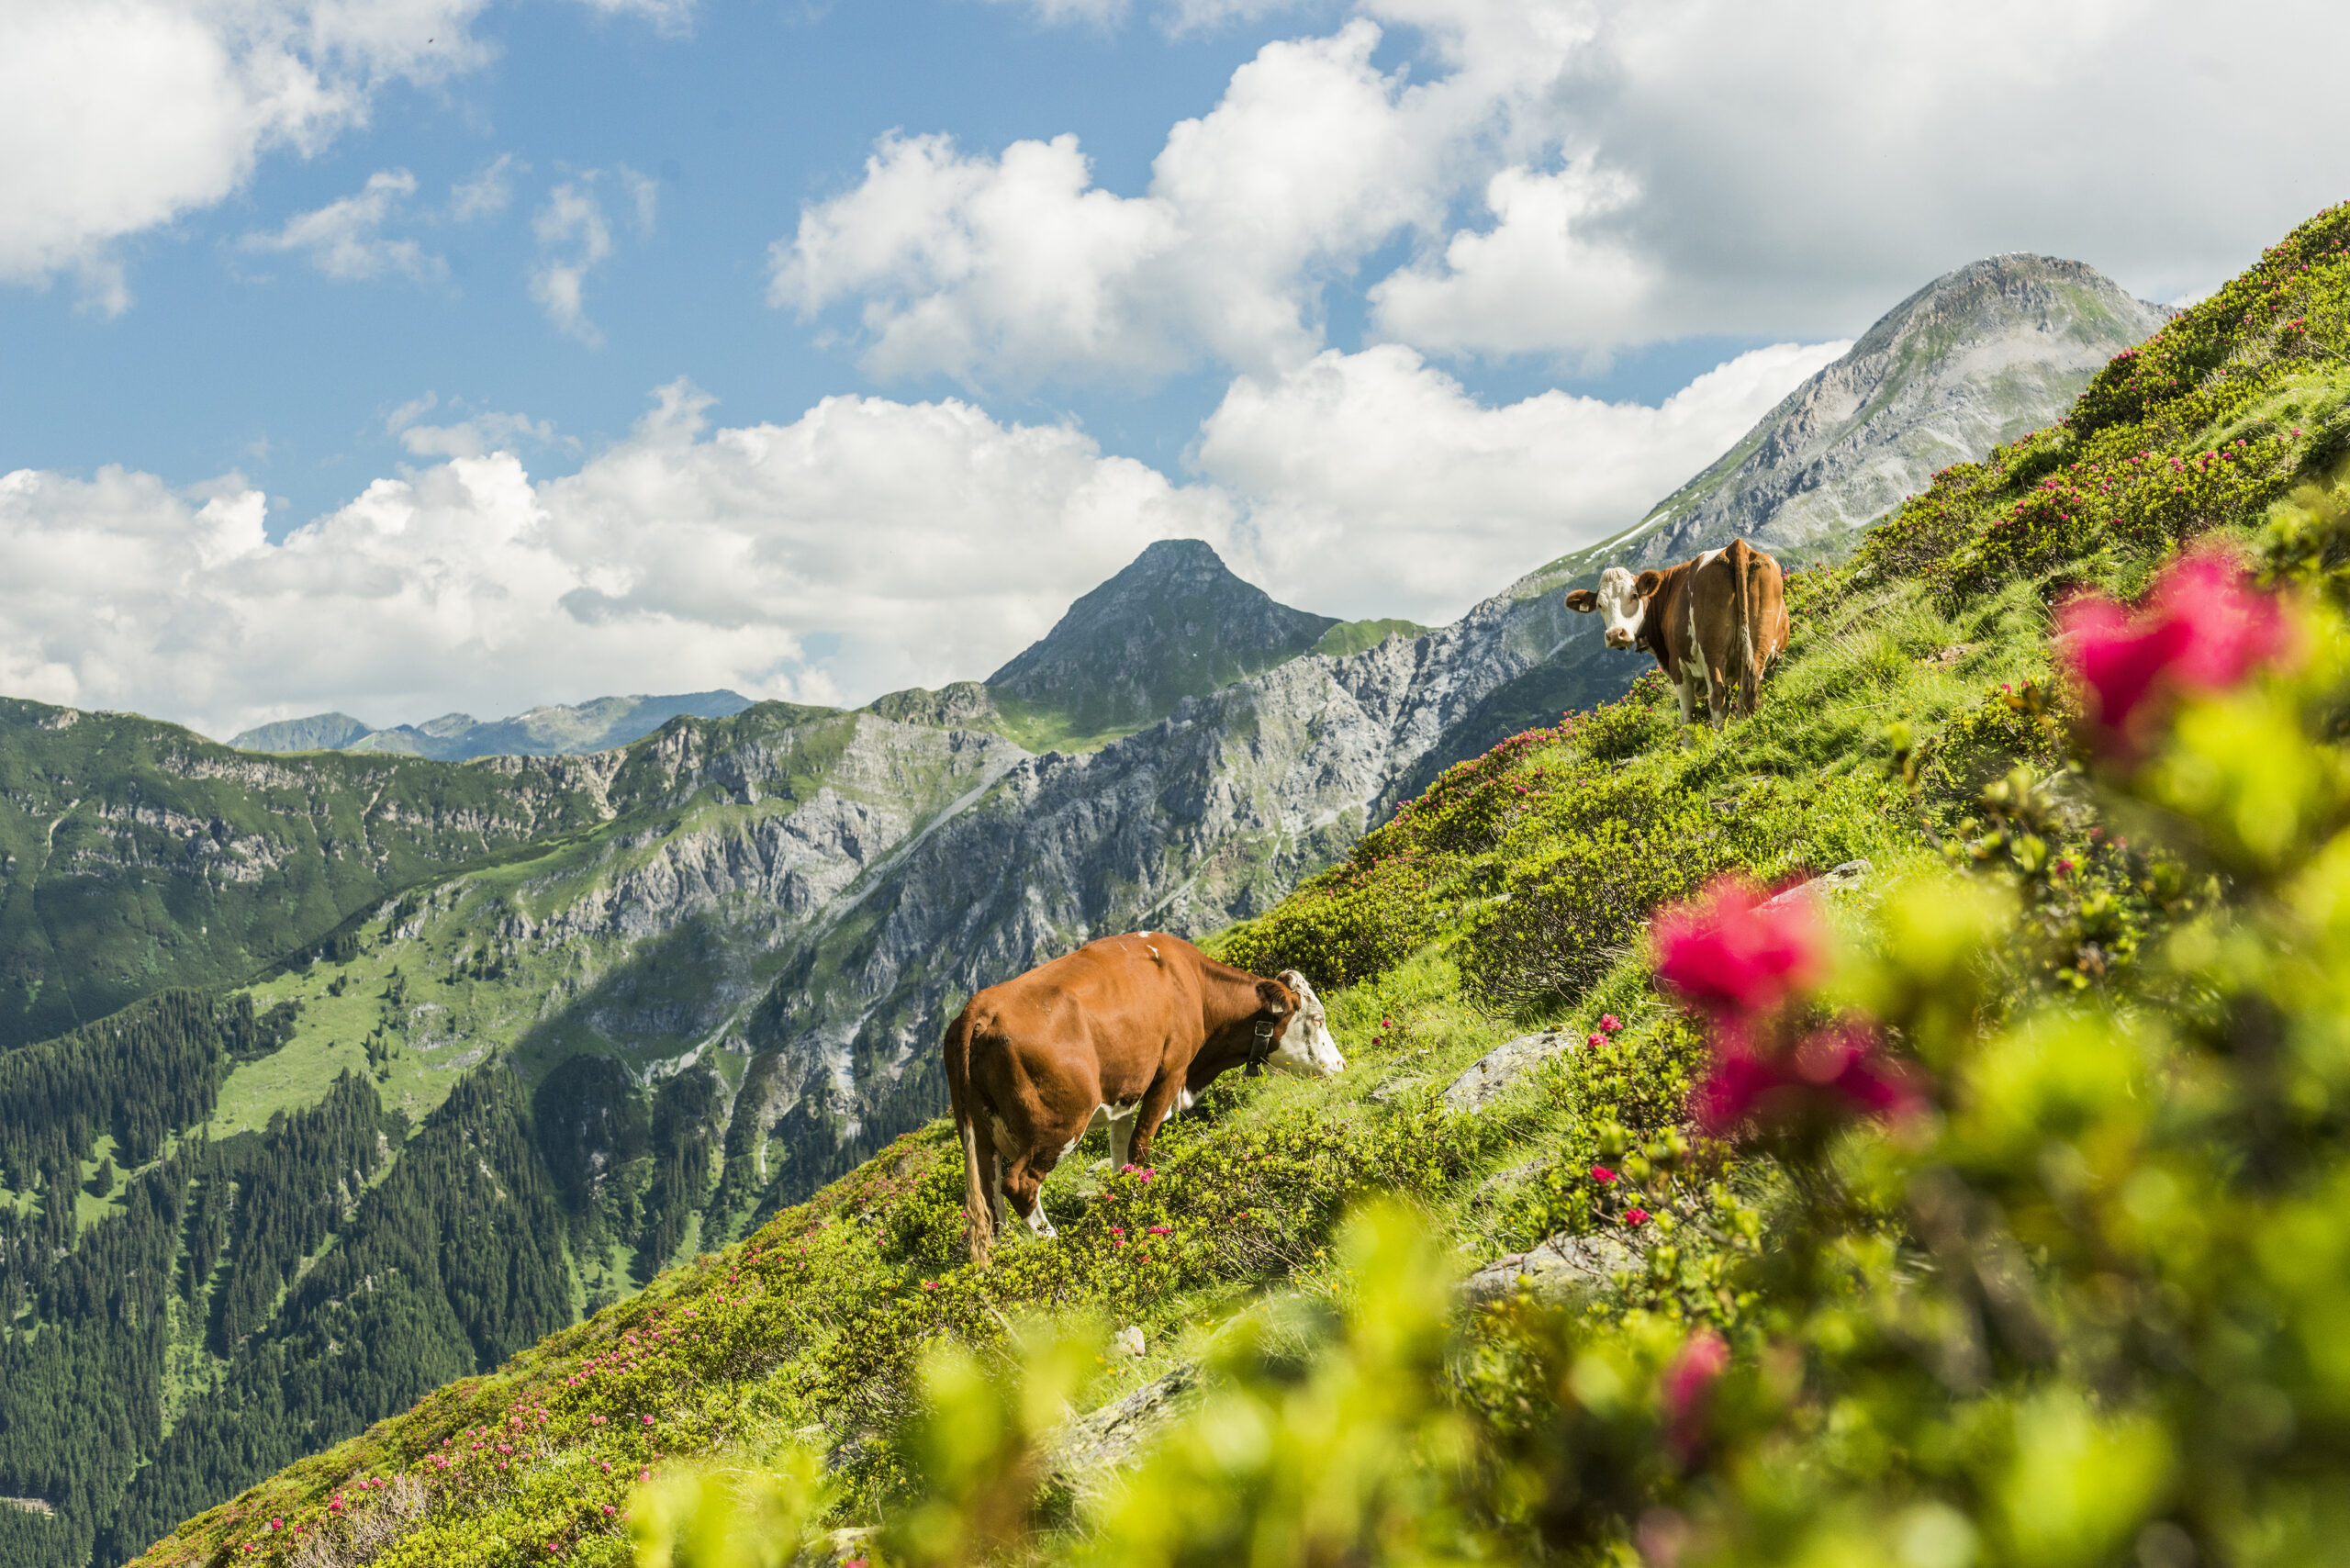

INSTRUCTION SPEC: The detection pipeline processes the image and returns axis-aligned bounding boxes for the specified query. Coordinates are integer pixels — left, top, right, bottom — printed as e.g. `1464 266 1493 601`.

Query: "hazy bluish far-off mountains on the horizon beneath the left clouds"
230 691 750 762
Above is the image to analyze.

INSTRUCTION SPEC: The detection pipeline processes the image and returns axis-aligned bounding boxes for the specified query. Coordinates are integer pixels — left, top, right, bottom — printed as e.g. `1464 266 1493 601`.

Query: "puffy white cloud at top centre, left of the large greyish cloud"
768 0 1577 383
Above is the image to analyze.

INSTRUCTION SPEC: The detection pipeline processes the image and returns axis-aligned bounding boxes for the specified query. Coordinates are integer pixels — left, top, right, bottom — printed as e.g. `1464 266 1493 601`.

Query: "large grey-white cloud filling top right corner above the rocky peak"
1372 0 2350 357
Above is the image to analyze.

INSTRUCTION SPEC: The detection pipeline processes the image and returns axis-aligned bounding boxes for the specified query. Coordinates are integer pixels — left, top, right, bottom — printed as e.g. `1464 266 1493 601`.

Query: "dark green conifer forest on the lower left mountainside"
0 990 582 1568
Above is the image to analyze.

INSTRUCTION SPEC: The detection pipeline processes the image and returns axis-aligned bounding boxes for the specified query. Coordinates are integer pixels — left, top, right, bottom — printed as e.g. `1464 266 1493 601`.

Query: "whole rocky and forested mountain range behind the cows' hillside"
0 256 2160 1568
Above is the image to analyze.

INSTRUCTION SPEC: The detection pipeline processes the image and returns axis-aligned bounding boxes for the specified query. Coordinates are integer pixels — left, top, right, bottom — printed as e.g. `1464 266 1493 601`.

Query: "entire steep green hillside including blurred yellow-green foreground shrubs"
114 209 2350 1565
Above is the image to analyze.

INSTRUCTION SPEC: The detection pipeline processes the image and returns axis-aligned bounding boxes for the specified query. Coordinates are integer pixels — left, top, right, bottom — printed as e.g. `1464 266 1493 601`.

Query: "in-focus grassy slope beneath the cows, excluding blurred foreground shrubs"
118 209 2350 1565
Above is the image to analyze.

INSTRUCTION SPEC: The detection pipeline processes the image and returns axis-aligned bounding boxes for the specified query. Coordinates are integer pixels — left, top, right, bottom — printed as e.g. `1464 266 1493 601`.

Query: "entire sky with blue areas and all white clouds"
0 0 2343 734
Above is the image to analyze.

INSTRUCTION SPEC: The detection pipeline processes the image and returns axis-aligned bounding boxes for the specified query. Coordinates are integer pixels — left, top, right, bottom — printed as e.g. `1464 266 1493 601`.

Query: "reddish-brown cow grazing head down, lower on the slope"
945 931 1347 1262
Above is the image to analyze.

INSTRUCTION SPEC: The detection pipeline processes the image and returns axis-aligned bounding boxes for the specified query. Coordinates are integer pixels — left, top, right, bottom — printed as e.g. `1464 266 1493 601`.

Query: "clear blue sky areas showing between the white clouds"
0 0 1772 533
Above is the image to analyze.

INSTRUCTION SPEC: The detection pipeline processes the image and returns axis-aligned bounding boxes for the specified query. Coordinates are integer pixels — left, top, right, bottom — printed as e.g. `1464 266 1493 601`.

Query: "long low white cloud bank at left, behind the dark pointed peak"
0 383 1231 736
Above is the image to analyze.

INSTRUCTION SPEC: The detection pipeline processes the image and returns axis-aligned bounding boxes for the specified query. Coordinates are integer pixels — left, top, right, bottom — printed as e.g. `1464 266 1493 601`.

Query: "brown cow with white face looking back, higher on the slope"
1568 538 1791 729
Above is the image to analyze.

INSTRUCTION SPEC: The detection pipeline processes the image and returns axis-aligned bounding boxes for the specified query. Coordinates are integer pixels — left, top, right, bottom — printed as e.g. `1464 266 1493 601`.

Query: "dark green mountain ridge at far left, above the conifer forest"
0 699 604 1048
